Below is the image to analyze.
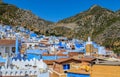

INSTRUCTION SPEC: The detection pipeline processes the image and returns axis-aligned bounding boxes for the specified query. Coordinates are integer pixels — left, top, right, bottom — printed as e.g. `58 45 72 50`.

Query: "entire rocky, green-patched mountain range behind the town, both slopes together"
0 2 120 53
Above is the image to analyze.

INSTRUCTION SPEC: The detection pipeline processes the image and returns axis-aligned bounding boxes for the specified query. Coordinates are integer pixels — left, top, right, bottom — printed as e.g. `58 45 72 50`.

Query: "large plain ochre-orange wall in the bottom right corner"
90 65 120 77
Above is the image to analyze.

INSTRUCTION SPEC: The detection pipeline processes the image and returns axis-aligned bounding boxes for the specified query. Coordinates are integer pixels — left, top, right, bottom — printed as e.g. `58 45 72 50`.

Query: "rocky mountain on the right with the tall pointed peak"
48 5 120 53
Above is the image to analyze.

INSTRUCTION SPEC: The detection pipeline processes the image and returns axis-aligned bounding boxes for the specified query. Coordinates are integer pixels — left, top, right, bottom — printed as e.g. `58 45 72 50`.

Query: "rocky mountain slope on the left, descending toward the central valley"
0 2 52 33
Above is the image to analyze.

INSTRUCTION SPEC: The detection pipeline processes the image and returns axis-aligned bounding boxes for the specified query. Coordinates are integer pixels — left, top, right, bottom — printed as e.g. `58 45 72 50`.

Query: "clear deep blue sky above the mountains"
3 0 120 22
